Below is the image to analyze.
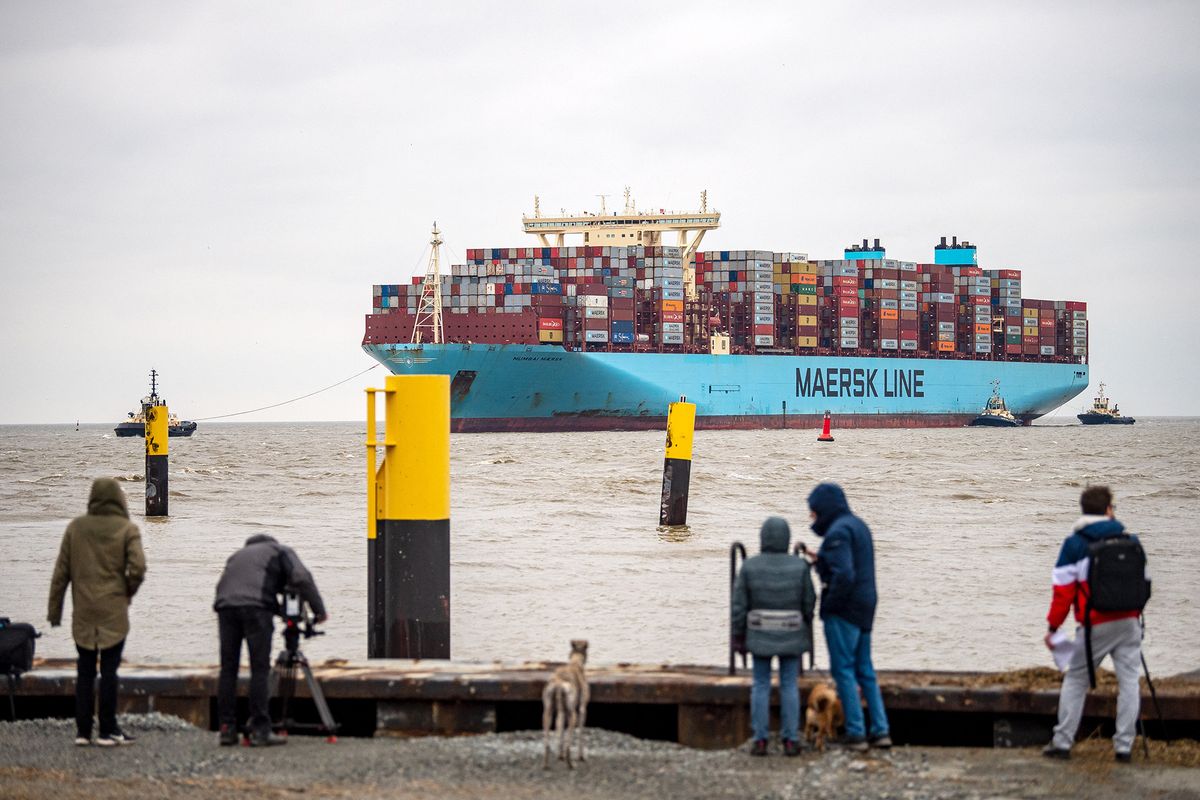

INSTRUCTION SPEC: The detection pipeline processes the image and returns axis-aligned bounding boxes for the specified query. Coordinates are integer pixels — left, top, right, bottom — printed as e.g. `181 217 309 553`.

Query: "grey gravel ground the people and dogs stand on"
0 714 1200 800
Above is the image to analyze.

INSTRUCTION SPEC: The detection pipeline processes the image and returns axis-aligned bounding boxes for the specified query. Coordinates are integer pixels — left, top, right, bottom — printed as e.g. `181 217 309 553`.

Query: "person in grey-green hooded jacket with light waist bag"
730 517 816 756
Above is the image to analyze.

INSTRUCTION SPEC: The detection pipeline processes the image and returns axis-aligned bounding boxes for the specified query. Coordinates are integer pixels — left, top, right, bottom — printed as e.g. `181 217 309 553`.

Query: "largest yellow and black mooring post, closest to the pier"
367 375 450 658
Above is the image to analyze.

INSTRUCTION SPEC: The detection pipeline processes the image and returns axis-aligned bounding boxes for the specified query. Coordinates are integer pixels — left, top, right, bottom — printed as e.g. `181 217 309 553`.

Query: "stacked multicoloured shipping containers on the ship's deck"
364 239 1087 363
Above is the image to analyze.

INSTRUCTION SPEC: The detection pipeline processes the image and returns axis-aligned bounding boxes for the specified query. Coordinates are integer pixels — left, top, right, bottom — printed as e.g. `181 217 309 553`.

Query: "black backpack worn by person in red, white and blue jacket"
1084 534 1150 688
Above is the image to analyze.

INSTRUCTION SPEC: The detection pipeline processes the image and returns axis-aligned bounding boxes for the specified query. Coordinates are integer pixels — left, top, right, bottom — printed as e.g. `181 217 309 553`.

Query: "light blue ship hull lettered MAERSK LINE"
364 344 1088 432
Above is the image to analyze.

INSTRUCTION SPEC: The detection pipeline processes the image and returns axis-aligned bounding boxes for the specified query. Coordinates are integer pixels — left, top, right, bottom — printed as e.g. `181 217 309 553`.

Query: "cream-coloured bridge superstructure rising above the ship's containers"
521 187 721 300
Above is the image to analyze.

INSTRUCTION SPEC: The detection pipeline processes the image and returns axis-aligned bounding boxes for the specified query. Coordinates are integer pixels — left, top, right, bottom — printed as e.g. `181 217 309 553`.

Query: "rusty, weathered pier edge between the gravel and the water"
11 660 1200 748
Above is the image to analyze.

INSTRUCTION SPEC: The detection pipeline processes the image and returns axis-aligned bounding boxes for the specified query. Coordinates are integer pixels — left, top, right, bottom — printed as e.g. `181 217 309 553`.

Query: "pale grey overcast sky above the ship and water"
0 0 1200 423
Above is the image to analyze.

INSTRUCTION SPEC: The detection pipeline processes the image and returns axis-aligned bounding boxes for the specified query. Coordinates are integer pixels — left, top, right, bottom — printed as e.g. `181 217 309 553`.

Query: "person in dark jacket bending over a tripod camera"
212 534 329 746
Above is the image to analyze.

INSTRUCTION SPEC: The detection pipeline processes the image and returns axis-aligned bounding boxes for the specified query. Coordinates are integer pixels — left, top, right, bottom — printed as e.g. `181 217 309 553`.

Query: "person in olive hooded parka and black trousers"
48 477 146 746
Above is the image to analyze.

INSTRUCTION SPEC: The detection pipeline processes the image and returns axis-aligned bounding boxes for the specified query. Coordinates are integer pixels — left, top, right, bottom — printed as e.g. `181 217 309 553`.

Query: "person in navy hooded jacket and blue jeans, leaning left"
809 483 892 752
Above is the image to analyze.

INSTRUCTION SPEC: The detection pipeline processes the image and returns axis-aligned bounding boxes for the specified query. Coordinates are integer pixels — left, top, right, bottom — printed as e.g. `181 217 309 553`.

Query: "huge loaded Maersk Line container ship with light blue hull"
362 192 1088 432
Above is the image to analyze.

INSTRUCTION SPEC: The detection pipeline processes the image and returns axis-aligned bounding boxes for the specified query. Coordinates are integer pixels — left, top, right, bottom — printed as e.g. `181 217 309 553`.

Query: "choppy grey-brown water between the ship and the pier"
0 420 1200 675
